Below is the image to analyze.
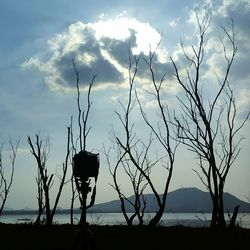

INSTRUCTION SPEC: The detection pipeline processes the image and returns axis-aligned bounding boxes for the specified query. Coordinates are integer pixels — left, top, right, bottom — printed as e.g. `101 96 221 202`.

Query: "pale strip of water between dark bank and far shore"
0 213 250 229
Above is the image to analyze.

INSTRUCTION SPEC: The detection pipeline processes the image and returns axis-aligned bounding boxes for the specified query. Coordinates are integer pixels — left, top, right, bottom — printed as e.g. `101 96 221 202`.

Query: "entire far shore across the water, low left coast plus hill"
3 187 250 215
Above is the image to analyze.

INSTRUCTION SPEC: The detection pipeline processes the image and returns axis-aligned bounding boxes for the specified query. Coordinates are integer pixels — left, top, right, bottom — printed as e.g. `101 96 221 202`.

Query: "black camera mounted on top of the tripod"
73 151 100 180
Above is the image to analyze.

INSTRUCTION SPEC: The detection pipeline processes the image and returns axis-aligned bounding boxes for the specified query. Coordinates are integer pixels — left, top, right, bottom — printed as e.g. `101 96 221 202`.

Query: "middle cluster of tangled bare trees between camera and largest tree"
106 48 178 226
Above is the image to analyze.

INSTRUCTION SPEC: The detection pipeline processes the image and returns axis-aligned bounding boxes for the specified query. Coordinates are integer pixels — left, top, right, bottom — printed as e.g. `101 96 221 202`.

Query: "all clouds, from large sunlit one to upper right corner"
22 3 250 121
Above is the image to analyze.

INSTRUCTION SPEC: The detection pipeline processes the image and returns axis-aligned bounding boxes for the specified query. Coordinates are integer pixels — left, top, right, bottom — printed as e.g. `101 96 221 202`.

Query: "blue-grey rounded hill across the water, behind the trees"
88 188 250 213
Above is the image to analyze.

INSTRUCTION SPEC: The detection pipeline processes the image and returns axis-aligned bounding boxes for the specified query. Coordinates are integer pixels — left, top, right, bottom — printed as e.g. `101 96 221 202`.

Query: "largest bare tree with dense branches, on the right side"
171 12 249 228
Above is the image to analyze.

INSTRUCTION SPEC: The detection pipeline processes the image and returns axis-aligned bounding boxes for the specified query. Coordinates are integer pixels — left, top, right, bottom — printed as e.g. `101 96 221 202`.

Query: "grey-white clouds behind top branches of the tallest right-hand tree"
162 0 250 119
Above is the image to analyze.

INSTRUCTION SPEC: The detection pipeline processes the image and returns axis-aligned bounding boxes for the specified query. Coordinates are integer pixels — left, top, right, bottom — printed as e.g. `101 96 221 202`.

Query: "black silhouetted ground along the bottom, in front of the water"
0 224 250 250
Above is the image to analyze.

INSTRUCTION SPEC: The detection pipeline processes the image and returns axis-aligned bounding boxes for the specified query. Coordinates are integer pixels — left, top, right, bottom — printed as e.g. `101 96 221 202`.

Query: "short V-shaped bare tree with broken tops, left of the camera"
28 127 70 225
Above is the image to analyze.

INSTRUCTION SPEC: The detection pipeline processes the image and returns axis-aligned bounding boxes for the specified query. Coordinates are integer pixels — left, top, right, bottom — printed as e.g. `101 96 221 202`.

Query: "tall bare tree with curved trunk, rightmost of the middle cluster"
136 49 179 226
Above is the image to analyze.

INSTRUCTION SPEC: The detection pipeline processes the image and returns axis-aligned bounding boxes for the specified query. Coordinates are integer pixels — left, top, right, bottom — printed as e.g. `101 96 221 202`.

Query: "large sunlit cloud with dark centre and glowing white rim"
22 16 167 91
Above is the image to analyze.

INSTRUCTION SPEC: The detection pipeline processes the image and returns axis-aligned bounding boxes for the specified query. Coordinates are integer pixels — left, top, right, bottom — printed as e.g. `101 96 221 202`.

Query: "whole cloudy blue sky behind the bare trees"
0 0 250 208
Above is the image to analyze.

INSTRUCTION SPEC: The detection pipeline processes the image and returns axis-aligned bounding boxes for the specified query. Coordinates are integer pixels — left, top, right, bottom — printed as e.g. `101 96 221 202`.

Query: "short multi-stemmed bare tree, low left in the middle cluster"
103 139 151 226
